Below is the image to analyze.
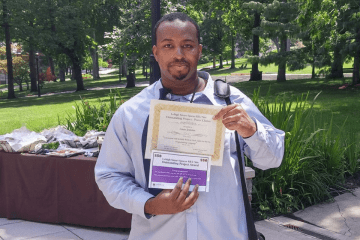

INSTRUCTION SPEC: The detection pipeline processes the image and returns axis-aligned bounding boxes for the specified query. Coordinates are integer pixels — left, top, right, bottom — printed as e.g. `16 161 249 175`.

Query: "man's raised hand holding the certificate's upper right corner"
213 104 256 138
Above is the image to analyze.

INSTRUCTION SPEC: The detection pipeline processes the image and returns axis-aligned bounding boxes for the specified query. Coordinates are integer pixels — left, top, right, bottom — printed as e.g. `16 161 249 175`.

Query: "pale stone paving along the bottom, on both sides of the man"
0 188 360 240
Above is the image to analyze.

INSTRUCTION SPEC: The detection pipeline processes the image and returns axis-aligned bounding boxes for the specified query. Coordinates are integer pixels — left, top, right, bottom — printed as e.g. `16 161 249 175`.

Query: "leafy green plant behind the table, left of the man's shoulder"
58 89 124 136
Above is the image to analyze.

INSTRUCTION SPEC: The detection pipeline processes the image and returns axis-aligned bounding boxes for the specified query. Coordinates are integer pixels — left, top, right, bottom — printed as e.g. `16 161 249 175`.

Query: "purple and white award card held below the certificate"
149 150 211 192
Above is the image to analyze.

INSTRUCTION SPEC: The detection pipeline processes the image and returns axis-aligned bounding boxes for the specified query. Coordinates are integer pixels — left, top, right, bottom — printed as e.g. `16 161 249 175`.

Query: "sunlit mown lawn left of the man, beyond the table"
0 85 143 135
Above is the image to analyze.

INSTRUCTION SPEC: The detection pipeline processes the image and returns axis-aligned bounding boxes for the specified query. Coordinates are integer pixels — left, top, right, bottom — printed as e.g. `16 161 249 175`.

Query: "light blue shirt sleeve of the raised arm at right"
234 95 285 170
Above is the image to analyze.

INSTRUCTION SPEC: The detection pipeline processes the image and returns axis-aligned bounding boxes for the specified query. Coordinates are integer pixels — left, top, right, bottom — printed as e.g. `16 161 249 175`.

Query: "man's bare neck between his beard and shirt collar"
162 74 206 96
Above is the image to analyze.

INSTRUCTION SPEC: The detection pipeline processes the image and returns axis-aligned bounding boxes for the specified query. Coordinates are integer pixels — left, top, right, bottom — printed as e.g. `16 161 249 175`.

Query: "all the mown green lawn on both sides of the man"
0 67 360 141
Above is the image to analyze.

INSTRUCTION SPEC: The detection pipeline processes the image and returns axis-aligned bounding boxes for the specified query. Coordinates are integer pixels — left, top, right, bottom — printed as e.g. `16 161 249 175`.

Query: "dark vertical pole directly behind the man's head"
150 0 161 84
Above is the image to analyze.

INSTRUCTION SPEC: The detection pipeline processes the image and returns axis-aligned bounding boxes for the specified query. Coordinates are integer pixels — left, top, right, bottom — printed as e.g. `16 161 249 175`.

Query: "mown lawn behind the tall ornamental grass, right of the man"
234 78 360 139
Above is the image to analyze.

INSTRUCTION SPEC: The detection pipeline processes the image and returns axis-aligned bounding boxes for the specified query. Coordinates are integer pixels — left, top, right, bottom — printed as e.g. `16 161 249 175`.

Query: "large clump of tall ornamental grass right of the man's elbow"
247 88 360 218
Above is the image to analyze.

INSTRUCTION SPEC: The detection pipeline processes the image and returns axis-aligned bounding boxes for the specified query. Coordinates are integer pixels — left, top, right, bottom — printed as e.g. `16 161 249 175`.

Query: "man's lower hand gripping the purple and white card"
145 178 199 215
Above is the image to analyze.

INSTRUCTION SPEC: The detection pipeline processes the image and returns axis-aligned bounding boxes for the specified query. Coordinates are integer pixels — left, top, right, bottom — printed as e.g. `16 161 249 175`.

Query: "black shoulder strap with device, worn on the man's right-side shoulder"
214 79 265 240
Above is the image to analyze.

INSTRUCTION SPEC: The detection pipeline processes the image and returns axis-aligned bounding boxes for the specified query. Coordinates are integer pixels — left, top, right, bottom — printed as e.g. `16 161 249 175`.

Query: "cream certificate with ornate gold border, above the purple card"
145 100 225 166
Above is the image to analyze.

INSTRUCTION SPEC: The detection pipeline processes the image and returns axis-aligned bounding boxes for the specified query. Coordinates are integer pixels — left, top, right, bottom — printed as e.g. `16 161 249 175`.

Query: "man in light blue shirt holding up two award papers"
95 13 284 240
